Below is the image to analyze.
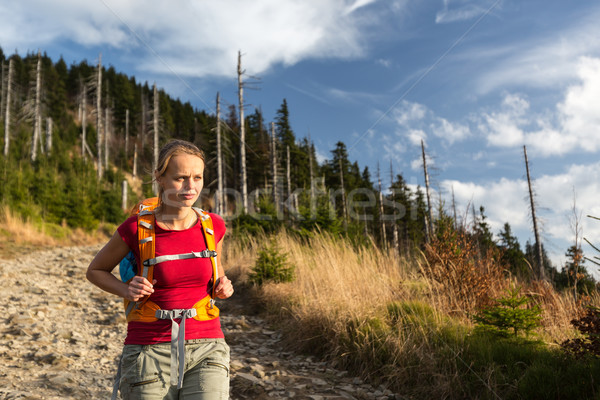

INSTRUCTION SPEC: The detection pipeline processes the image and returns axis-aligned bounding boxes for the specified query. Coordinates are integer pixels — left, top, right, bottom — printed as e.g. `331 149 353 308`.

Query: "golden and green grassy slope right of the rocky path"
225 233 600 399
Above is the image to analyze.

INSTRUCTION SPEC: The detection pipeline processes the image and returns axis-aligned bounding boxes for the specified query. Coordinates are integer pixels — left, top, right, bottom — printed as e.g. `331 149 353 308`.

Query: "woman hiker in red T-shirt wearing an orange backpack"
87 140 233 400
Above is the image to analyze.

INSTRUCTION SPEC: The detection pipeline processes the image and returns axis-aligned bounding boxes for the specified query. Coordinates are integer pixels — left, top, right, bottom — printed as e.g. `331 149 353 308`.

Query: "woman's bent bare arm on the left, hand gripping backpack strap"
86 232 154 301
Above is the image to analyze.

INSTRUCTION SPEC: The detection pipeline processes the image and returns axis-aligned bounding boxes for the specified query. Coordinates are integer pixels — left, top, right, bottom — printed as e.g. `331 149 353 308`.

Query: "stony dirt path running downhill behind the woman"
0 247 400 400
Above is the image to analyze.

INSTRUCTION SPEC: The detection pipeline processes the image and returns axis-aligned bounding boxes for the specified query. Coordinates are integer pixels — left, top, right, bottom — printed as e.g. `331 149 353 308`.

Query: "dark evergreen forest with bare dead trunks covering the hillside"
0 49 596 293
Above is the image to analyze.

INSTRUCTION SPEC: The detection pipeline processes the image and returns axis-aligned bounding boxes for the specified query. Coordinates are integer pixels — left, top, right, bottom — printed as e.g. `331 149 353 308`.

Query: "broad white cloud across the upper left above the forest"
0 0 394 77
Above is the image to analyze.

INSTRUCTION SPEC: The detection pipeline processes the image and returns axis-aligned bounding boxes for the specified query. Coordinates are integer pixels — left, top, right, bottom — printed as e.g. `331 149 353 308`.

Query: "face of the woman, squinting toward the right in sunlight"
157 153 204 208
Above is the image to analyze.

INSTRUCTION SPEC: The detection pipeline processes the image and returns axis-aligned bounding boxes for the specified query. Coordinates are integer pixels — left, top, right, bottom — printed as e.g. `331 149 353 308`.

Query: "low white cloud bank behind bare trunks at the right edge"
441 162 600 270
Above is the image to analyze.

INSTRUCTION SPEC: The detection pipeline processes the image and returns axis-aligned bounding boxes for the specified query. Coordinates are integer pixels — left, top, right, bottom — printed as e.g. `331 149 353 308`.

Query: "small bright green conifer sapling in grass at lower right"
473 288 542 337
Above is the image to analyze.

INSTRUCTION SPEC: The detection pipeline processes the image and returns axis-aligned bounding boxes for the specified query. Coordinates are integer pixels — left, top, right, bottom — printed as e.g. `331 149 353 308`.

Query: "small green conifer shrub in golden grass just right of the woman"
249 240 296 285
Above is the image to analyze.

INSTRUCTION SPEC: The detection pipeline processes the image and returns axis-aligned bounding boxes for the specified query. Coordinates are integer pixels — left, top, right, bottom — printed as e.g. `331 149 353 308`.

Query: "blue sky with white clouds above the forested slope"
0 0 600 270
